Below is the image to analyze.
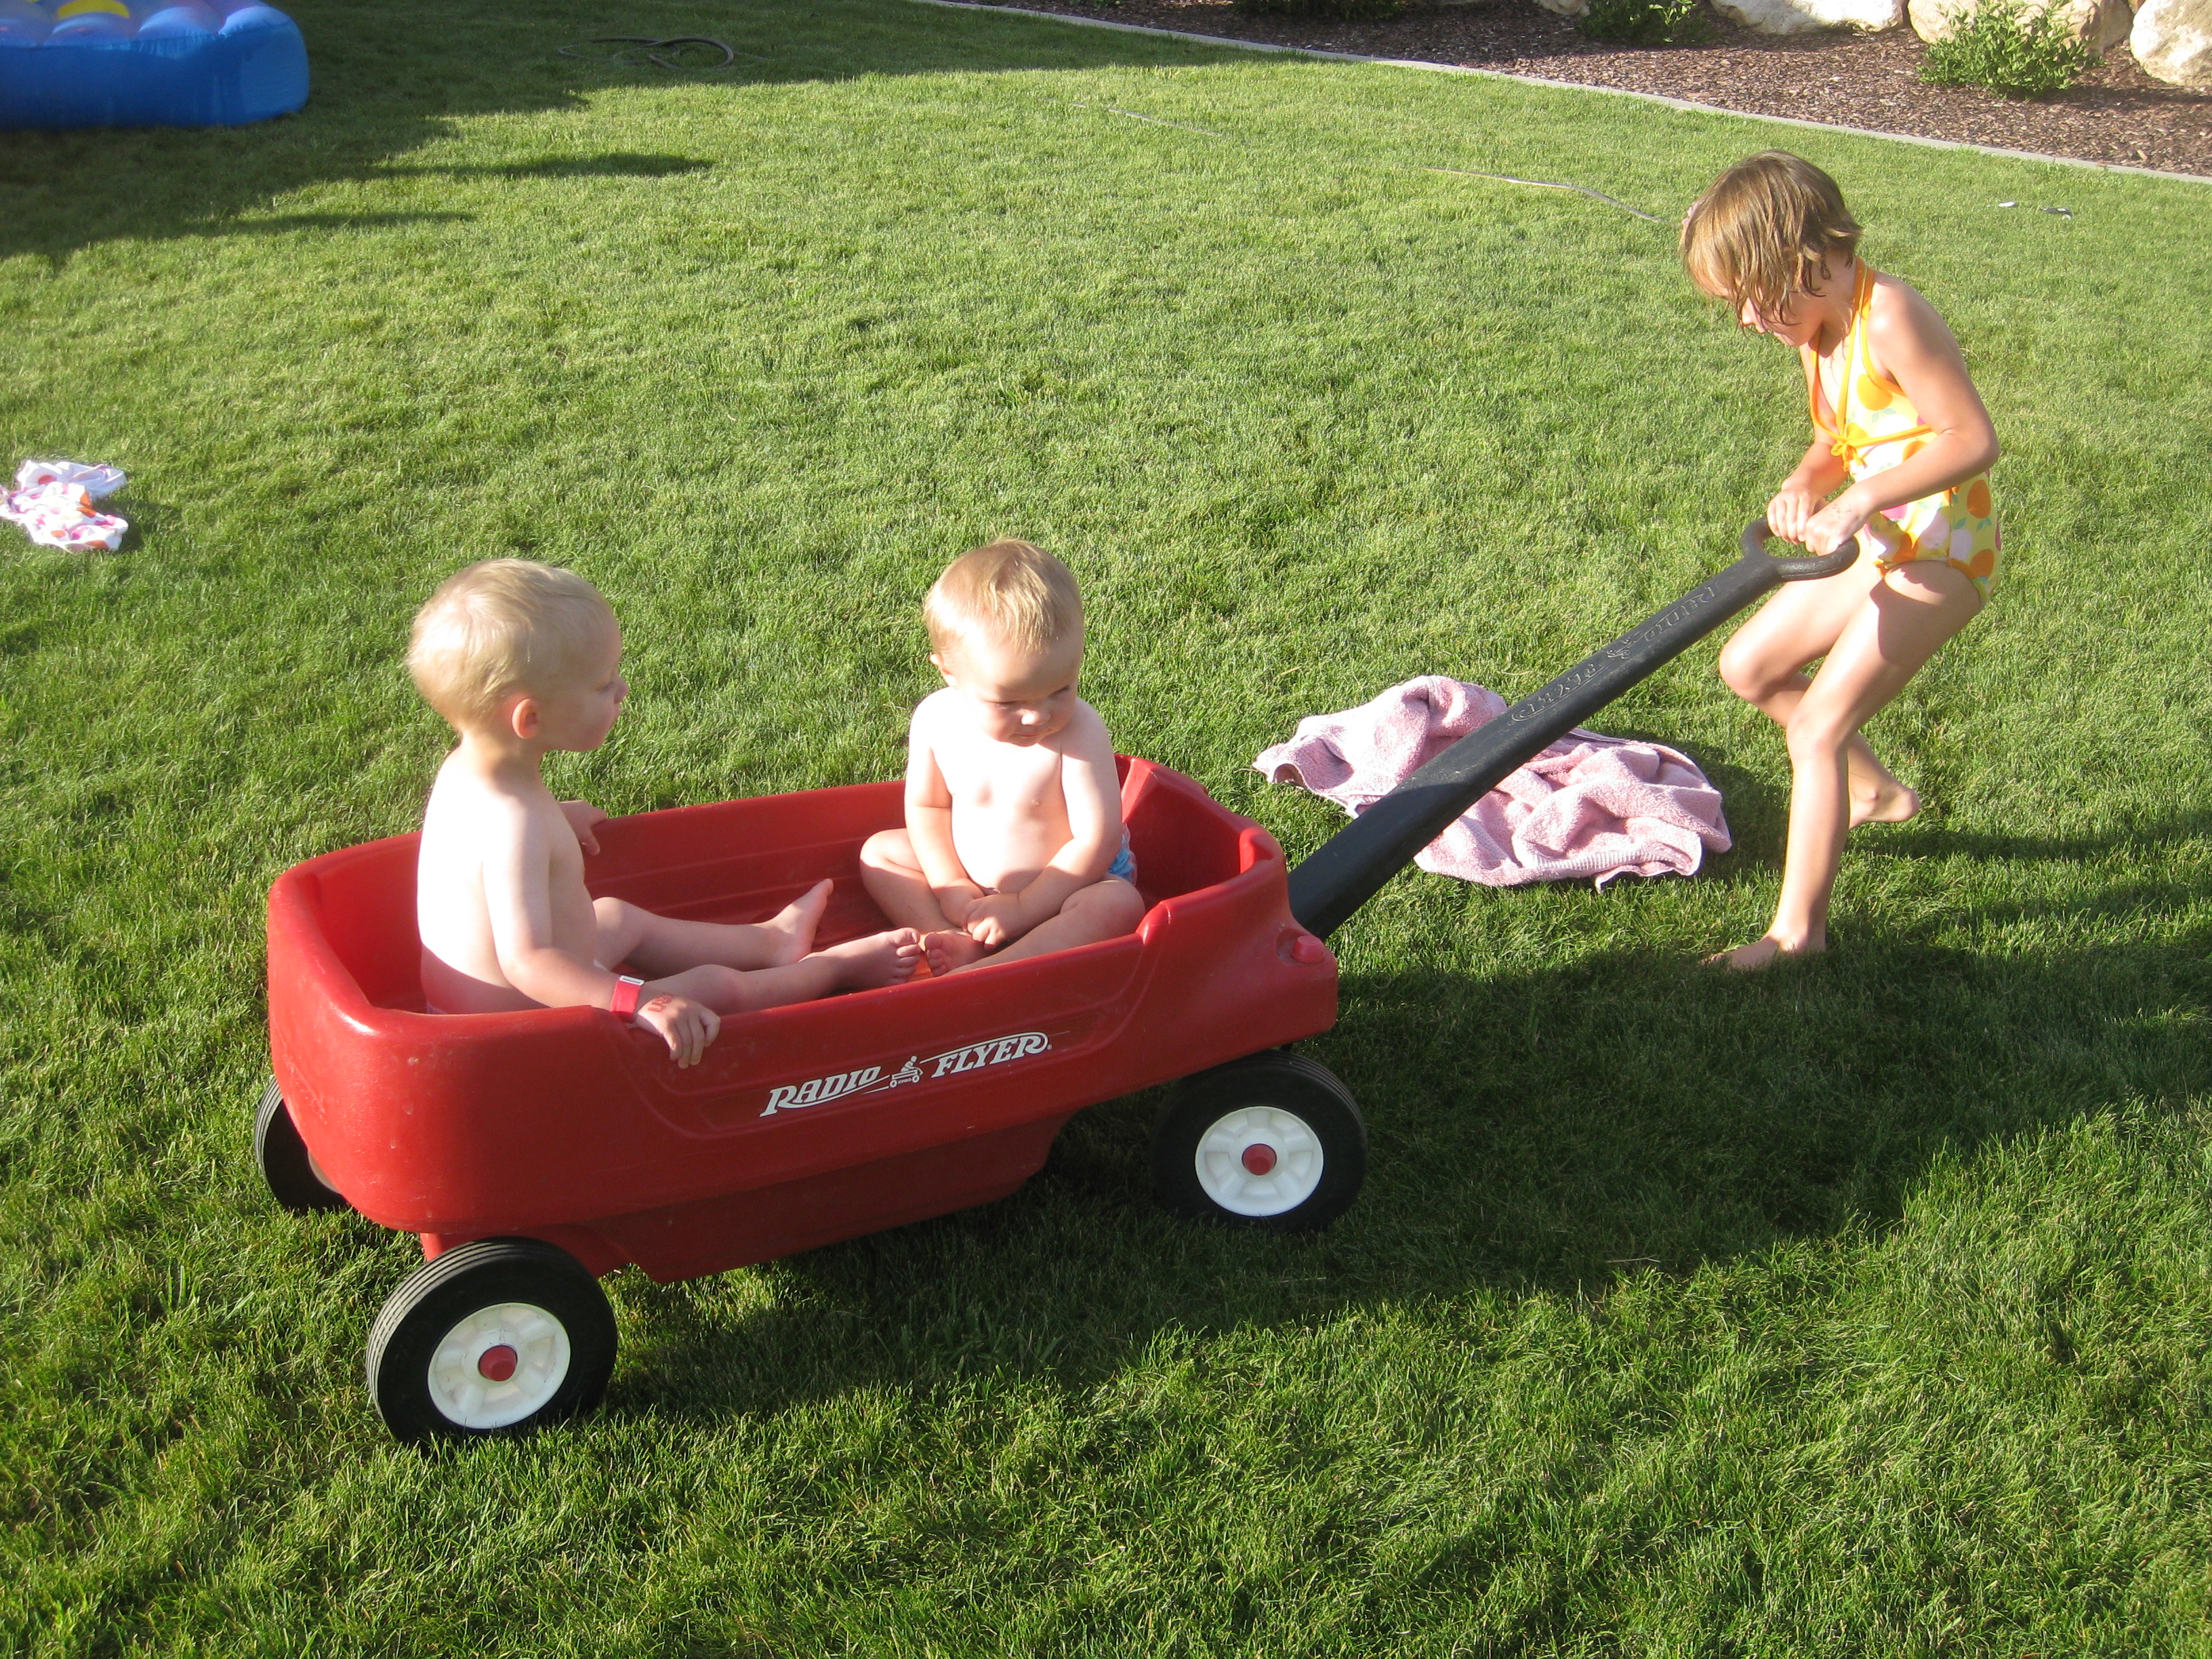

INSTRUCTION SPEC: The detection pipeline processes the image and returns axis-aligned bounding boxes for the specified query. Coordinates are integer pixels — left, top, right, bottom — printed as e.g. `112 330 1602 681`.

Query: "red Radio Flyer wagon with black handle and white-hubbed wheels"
254 525 1851 1438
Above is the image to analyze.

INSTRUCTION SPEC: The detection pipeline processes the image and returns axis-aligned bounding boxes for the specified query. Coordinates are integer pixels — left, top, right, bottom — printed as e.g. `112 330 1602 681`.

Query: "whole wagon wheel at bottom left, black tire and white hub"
369 1239 615 1440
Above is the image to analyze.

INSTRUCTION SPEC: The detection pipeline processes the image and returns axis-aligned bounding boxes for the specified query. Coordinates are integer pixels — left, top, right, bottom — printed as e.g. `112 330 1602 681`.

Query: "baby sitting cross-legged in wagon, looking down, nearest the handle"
861 542 1143 973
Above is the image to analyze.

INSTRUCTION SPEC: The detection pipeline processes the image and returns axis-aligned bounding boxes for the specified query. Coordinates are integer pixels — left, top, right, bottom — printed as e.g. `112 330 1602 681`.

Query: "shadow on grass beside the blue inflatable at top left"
0 0 1246 261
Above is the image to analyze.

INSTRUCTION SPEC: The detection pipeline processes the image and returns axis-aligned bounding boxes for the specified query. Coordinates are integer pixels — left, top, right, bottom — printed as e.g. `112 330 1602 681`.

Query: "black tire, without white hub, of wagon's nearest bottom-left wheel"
369 1239 615 1440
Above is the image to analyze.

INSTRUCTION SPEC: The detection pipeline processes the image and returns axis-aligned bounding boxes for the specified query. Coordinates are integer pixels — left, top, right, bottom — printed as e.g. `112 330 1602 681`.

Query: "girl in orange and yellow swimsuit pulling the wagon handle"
1681 150 1997 969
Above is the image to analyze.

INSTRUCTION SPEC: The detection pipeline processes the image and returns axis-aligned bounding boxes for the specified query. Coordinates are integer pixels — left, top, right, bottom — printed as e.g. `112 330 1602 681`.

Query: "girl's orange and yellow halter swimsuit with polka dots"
1799 261 1997 600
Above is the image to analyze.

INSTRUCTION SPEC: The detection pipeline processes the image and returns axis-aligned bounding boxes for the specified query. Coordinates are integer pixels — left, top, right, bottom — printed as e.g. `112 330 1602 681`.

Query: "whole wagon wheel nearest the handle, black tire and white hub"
1153 1050 1367 1232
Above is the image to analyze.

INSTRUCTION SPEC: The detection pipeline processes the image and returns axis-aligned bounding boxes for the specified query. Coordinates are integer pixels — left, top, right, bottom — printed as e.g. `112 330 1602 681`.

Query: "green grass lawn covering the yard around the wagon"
0 0 2212 1659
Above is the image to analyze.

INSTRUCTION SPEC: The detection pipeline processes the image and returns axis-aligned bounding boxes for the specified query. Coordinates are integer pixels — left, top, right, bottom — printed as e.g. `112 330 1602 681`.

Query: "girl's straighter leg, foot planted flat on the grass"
1712 562 1982 969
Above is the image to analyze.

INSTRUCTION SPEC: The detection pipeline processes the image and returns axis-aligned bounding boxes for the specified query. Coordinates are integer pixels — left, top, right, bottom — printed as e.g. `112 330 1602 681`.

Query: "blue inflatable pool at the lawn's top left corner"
0 0 308 128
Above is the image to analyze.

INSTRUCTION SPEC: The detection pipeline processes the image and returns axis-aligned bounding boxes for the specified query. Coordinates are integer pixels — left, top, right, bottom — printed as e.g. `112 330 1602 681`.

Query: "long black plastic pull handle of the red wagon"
1290 518 1858 938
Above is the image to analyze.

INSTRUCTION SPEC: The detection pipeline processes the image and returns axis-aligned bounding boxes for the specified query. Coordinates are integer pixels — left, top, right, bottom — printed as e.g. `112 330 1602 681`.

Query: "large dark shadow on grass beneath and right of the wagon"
613 825 2212 1420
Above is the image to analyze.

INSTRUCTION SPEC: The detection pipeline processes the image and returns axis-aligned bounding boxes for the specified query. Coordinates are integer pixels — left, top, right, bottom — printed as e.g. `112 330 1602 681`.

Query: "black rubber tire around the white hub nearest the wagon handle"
1153 1048 1367 1232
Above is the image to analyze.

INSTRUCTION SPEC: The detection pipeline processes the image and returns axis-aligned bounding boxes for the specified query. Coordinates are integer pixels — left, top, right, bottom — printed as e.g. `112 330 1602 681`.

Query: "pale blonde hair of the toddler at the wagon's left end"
407 560 615 726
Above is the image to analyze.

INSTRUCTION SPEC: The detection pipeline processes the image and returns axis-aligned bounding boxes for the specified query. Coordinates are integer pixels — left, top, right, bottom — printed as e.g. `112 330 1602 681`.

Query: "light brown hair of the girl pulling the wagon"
1681 150 1858 319
